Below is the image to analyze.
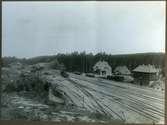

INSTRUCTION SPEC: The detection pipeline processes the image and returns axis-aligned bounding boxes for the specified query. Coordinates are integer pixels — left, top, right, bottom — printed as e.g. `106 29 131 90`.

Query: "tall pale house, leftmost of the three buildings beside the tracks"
93 61 112 77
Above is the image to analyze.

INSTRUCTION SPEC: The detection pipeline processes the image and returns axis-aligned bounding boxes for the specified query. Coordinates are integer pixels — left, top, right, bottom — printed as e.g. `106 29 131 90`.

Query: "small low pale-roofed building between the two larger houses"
114 66 131 75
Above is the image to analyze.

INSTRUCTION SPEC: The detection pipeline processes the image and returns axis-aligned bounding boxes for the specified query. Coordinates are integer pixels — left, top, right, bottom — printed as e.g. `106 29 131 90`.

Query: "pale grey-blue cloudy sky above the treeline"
2 1 165 58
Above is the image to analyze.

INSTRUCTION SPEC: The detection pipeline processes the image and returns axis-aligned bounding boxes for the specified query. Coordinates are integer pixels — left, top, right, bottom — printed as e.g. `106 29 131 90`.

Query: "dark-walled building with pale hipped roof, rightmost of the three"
133 64 157 85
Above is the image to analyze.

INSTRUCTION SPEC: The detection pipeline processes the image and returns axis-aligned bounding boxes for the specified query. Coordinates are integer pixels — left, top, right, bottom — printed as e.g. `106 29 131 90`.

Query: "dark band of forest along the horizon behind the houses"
2 52 165 72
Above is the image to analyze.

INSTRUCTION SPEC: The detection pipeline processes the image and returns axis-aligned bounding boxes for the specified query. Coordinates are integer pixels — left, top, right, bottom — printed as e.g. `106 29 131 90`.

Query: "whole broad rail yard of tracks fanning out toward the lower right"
39 71 164 123
